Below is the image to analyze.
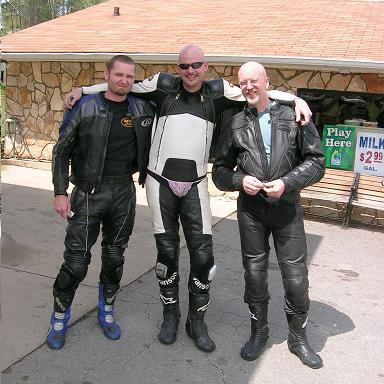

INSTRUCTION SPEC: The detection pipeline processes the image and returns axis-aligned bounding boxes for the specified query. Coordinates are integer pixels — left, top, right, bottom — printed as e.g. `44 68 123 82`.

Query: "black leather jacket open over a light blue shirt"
212 103 325 202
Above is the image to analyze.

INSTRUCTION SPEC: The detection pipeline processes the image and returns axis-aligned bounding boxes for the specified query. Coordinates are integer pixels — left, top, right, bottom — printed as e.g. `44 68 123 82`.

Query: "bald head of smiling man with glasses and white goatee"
238 61 269 112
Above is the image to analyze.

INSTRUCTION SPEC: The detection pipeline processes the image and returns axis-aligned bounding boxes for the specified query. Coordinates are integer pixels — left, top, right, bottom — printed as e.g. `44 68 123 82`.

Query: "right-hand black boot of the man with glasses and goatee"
287 313 323 369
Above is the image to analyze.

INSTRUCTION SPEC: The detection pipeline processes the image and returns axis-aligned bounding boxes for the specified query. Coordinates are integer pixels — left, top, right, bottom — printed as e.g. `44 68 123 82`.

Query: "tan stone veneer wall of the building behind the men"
3 61 384 160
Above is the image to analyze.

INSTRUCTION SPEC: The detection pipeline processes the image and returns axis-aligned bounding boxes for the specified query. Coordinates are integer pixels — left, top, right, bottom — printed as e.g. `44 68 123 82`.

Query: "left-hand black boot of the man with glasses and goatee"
240 304 269 361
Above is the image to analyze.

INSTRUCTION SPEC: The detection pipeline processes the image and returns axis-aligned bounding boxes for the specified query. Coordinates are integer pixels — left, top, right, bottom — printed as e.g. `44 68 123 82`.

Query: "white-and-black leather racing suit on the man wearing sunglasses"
83 73 295 303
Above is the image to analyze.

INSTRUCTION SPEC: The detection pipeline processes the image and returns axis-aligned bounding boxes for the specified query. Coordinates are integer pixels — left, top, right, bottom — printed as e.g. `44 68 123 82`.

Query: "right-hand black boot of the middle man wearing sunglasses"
185 292 216 352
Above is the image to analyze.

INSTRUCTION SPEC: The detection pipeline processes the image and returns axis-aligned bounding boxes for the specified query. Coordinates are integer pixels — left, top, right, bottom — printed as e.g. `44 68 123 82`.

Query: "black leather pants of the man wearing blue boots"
53 175 136 312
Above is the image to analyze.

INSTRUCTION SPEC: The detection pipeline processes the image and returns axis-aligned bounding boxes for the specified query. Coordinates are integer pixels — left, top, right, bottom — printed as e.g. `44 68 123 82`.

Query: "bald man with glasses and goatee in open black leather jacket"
213 62 324 368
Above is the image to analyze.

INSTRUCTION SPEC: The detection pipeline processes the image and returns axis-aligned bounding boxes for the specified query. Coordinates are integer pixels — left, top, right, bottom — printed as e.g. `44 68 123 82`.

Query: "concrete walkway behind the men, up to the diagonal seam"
0 162 236 370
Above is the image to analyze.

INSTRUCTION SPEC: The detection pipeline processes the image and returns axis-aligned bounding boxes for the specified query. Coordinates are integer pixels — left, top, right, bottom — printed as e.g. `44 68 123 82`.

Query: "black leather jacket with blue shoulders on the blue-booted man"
52 93 155 195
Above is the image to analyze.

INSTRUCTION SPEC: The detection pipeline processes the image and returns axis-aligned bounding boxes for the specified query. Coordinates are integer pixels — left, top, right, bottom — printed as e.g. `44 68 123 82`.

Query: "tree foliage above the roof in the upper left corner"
0 0 106 35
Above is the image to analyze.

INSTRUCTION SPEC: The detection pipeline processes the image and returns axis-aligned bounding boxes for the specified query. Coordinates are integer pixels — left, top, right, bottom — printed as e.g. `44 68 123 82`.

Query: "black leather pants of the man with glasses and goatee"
237 198 309 314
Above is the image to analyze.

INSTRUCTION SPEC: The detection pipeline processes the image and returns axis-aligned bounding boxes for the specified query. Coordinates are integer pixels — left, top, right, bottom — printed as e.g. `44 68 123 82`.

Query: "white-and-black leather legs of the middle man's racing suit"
146 175 214 293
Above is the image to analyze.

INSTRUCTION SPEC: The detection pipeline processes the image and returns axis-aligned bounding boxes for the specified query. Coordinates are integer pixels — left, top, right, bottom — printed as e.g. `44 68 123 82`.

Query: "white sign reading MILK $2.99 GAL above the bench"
354 128 384 176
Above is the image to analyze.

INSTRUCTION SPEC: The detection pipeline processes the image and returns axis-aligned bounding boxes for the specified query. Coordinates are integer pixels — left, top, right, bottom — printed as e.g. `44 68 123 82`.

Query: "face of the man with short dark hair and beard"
104 61 135 101
